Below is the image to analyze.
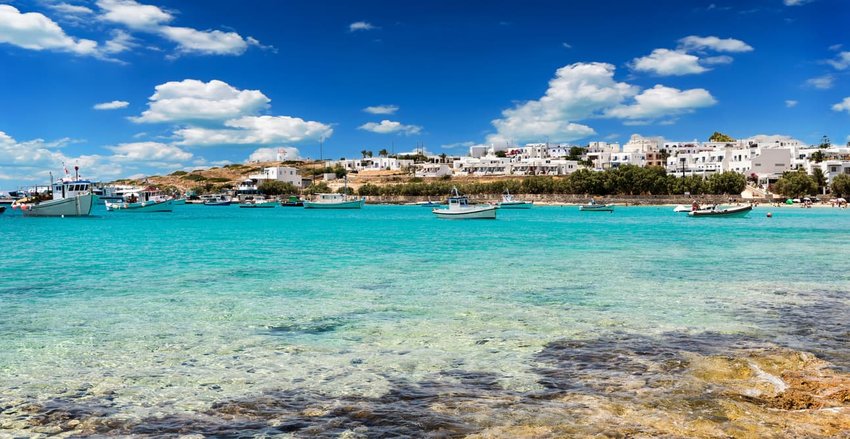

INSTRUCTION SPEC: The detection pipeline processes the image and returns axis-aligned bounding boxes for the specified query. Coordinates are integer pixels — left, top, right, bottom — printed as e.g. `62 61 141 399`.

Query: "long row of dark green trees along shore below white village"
358 165 747 196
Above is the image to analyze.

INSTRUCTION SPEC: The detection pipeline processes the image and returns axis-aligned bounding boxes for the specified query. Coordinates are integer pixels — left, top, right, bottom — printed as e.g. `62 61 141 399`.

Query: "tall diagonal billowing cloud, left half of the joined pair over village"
487 63 639 144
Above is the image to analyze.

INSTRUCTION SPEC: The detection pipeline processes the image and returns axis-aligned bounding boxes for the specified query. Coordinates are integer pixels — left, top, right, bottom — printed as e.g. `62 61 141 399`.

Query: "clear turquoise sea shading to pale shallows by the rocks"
0 205 850 437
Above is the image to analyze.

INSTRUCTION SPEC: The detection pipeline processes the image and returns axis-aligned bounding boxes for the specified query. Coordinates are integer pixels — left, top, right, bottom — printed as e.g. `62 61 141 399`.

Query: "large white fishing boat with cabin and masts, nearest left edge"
12 166 97 217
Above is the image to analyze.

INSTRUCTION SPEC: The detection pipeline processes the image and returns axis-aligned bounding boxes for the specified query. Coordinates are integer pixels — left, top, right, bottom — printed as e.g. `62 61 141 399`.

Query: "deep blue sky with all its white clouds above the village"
0 0 850 189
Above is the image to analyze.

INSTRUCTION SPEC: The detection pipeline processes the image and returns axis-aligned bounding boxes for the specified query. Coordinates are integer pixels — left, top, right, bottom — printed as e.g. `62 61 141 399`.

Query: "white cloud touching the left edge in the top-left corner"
0 4 97 56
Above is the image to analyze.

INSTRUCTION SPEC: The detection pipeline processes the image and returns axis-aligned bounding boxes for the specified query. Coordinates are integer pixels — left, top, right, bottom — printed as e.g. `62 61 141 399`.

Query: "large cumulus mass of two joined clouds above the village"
487 63 716 145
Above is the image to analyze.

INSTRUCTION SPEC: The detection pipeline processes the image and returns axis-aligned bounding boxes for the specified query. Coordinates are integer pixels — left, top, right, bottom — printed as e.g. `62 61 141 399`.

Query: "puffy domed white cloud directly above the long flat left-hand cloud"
131 79 271 123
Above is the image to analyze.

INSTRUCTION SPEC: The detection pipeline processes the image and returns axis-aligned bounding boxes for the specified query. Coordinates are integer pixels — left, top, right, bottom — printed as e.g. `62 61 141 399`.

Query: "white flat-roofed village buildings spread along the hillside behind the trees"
238 134 850 197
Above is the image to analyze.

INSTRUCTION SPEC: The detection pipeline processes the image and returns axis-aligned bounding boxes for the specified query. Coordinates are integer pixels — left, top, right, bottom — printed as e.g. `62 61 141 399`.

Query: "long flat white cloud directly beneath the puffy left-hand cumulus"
174 116 333 146
